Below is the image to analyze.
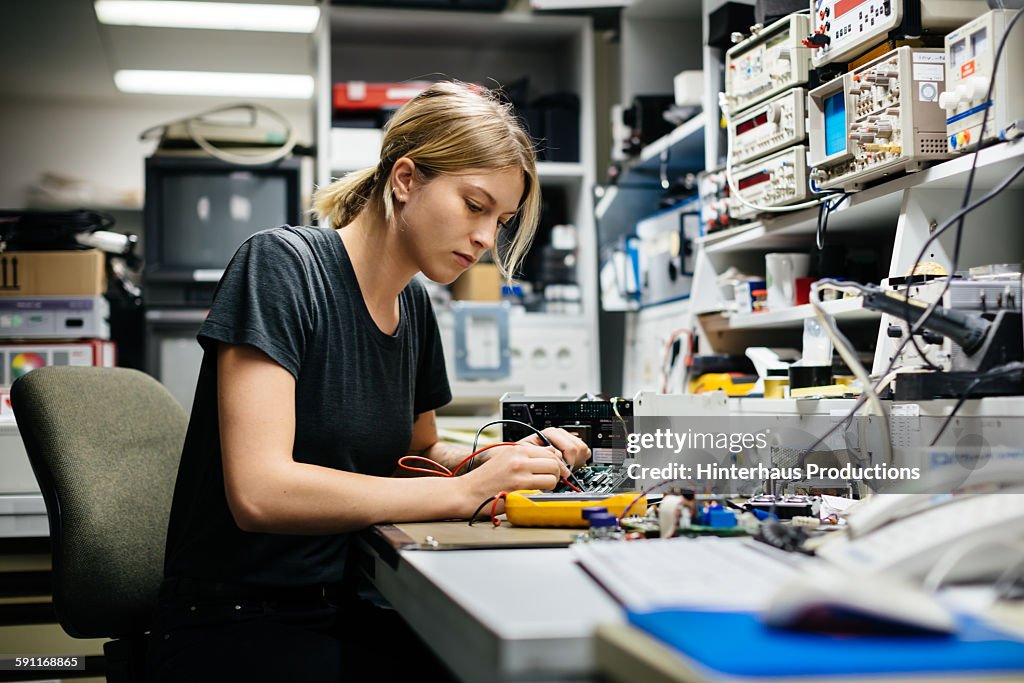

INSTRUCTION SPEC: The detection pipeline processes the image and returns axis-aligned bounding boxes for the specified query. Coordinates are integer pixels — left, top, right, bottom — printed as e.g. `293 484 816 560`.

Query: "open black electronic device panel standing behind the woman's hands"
502 394 633 465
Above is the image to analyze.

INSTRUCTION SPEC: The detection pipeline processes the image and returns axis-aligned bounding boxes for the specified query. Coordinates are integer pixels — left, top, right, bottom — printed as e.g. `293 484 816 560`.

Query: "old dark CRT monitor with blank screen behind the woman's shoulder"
145 156 301 283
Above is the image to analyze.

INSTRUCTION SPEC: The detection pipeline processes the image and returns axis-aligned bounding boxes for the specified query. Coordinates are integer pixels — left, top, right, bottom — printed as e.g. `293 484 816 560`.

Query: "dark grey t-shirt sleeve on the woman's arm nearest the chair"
199 228 313 379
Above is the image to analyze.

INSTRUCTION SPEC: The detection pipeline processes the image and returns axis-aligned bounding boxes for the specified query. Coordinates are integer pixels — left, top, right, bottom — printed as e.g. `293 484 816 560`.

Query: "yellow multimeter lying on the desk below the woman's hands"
505 490 647 528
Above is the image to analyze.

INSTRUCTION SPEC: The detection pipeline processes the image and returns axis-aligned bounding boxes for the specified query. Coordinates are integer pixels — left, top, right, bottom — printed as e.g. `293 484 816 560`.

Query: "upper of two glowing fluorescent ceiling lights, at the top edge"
93 0 319 33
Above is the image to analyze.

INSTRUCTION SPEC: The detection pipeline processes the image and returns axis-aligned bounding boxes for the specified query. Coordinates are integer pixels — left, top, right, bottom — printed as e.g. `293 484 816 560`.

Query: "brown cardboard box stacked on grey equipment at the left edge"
0 249 106 297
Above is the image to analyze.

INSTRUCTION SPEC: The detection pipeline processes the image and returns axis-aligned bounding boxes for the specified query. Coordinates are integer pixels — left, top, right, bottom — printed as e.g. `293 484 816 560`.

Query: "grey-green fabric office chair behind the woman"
10 366 187 683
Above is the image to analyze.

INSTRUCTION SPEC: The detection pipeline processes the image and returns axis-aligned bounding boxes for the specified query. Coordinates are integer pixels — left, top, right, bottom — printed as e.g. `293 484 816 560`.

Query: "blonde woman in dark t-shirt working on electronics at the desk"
152 83 589 681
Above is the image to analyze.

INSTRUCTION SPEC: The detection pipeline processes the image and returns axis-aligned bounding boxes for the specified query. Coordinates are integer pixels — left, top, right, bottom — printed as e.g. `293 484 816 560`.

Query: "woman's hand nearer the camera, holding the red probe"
459 443 569 507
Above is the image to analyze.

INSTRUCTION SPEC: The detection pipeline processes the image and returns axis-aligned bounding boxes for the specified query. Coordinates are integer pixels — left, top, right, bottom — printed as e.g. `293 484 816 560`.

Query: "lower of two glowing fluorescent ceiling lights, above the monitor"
114 70 313 99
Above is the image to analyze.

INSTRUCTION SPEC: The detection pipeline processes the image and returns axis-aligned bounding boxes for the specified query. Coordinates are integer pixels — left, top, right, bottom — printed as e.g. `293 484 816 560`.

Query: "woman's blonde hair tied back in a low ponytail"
313 81 541 280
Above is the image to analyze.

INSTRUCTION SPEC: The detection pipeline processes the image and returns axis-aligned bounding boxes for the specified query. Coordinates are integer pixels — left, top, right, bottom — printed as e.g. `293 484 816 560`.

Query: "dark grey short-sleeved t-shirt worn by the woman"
165 226 452 587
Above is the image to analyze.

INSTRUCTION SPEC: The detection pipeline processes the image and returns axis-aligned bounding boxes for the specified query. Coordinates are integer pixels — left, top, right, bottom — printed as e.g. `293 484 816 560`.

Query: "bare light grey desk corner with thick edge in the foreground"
364 522 623 682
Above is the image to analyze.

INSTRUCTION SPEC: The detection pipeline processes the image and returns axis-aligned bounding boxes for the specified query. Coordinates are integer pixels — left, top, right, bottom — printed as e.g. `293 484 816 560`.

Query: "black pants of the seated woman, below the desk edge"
148 581 454 683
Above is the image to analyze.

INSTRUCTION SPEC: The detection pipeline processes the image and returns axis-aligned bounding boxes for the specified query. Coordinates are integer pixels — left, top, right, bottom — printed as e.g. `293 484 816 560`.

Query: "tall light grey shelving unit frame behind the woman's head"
315 6 600 400
